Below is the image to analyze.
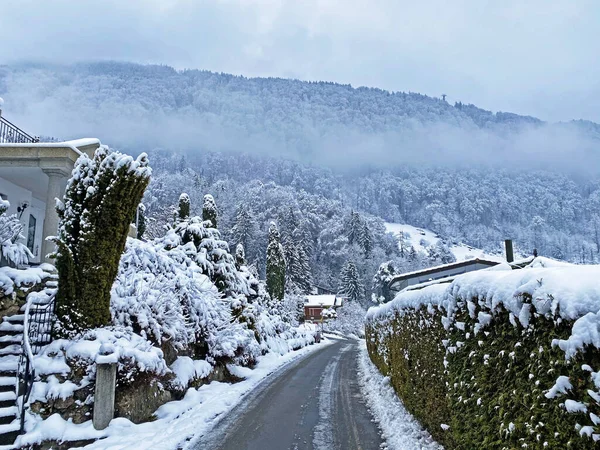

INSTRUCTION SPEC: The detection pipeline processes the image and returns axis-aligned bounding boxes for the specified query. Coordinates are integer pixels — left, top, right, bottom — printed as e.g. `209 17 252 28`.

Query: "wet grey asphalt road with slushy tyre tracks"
194 340 382 450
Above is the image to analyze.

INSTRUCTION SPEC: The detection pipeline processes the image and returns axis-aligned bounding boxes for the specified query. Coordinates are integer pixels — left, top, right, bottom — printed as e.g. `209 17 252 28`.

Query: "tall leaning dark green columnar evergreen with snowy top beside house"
55 147 150 330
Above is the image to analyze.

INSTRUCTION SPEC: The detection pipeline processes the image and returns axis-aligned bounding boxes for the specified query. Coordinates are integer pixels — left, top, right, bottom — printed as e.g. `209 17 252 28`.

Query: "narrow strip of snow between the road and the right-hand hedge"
358 340 443 450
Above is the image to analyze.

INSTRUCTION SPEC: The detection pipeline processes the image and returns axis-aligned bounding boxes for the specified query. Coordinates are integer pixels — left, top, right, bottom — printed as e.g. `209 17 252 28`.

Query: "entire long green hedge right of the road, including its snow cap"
367 258 600 449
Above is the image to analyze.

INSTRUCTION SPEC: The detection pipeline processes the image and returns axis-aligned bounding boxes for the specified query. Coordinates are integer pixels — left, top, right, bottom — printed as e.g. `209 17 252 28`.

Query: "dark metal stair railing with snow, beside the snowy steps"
17 290 55 432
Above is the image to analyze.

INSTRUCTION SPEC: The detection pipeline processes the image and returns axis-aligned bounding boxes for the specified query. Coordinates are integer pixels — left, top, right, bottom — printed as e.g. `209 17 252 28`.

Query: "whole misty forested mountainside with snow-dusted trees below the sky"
0 62 600 297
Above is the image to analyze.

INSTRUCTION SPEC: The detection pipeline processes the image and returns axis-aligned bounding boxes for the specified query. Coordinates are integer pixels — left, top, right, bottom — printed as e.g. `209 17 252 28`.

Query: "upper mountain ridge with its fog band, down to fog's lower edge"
0 62 600 175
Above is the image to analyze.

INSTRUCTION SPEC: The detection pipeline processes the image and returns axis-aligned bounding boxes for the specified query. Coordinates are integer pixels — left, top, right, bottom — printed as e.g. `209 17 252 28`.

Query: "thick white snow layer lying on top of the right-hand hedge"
367 258 600 358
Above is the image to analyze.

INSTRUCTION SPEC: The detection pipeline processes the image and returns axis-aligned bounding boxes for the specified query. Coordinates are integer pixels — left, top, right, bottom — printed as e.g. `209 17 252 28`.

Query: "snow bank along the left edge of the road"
20 339 332 450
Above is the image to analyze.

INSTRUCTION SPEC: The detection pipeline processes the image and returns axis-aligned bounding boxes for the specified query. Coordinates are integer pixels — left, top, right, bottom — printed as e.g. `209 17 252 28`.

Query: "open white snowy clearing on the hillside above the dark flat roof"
385 222 504 262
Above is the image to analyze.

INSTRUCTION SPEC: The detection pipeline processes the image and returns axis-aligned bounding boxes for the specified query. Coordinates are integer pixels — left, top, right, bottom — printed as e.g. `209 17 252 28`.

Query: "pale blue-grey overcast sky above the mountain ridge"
0 0 600 122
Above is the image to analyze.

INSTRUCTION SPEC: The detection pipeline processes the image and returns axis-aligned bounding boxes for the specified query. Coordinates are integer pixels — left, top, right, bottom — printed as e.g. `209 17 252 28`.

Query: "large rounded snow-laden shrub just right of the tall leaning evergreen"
111 236 258 362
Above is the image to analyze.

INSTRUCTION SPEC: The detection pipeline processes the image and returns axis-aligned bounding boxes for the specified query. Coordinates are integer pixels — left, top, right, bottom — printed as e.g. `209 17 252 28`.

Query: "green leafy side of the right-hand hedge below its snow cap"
366 274 600 450
